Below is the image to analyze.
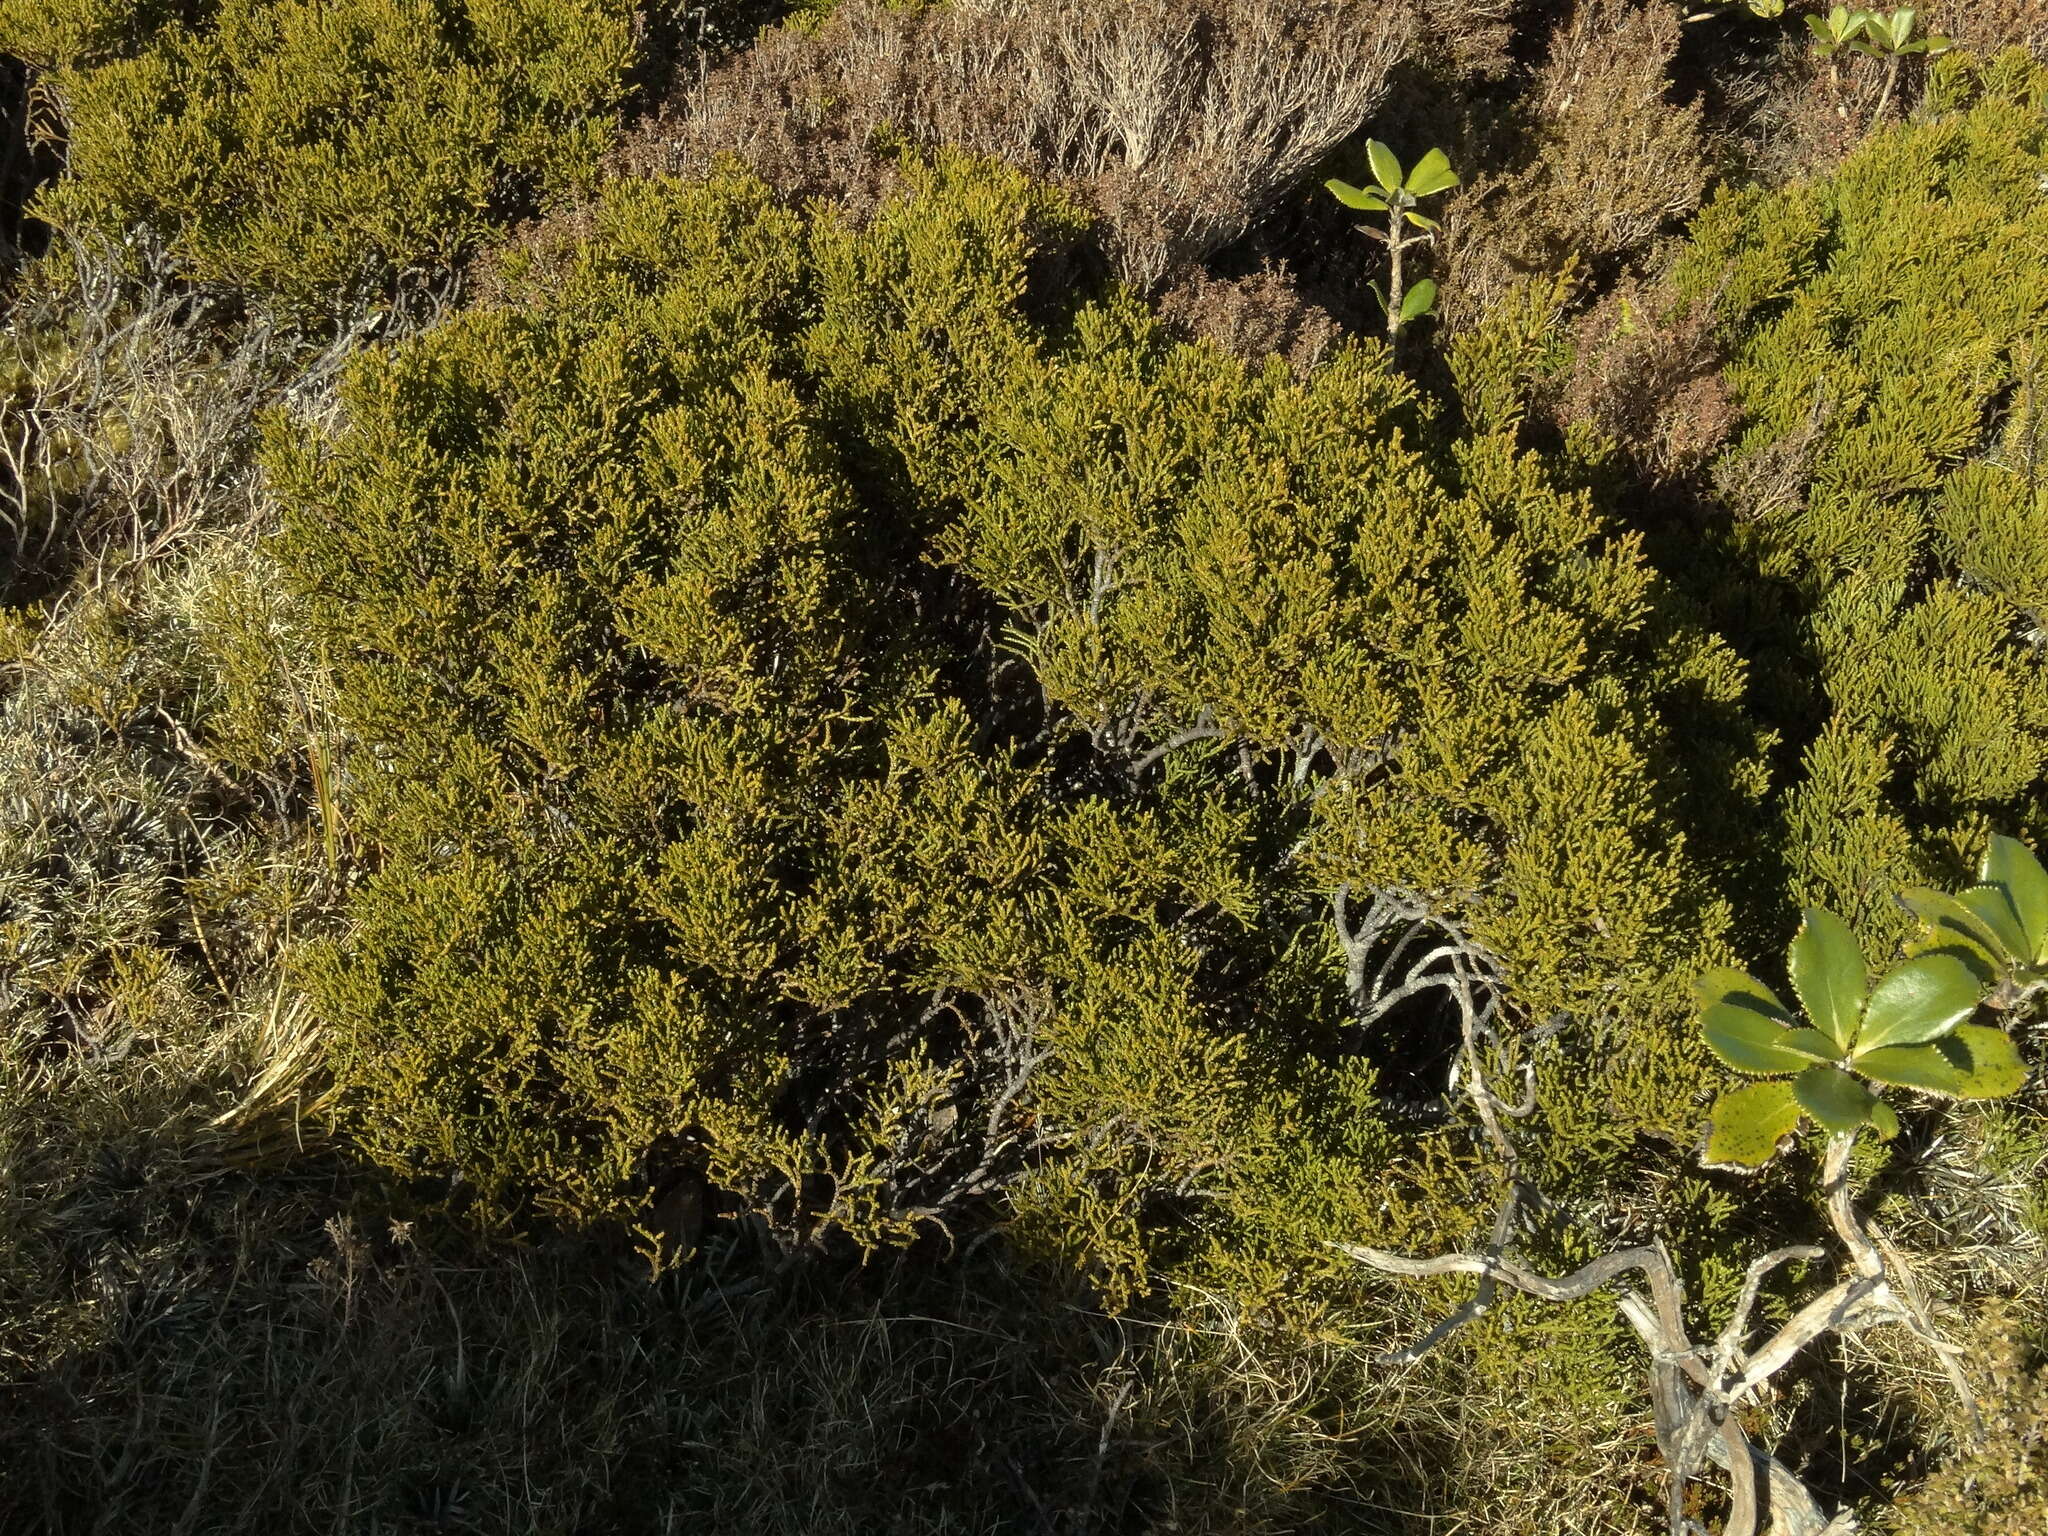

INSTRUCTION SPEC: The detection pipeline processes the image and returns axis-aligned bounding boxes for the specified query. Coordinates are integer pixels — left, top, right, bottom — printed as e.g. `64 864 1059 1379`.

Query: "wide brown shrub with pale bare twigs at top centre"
623 0 1505 289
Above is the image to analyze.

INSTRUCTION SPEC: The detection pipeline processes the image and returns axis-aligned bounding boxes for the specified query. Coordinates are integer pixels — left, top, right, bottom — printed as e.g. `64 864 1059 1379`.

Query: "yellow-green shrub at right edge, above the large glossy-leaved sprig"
1677 55 2048 946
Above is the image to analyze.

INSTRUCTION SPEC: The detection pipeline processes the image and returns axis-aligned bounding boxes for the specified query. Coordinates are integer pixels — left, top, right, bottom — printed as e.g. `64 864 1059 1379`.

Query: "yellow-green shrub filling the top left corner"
0 0 631 311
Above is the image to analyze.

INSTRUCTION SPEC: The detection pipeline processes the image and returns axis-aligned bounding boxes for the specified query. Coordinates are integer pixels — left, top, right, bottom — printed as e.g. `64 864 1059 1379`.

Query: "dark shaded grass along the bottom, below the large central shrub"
0 1196 1174 1536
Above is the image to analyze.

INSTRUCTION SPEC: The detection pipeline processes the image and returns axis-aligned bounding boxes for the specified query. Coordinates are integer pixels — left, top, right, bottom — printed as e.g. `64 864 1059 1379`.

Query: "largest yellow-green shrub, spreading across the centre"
280 162 1769 1409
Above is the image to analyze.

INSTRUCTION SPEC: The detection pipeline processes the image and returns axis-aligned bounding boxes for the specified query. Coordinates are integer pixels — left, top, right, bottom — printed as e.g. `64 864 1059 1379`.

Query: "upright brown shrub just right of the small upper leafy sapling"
1442 0 1708 326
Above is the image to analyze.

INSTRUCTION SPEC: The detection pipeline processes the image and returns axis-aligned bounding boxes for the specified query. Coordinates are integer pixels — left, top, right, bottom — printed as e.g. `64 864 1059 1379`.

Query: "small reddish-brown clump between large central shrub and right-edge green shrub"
1554 276 1737 479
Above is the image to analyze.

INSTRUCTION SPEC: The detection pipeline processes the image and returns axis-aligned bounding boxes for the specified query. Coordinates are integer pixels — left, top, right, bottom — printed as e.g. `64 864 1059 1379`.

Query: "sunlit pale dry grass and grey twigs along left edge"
0 246 360 1122
